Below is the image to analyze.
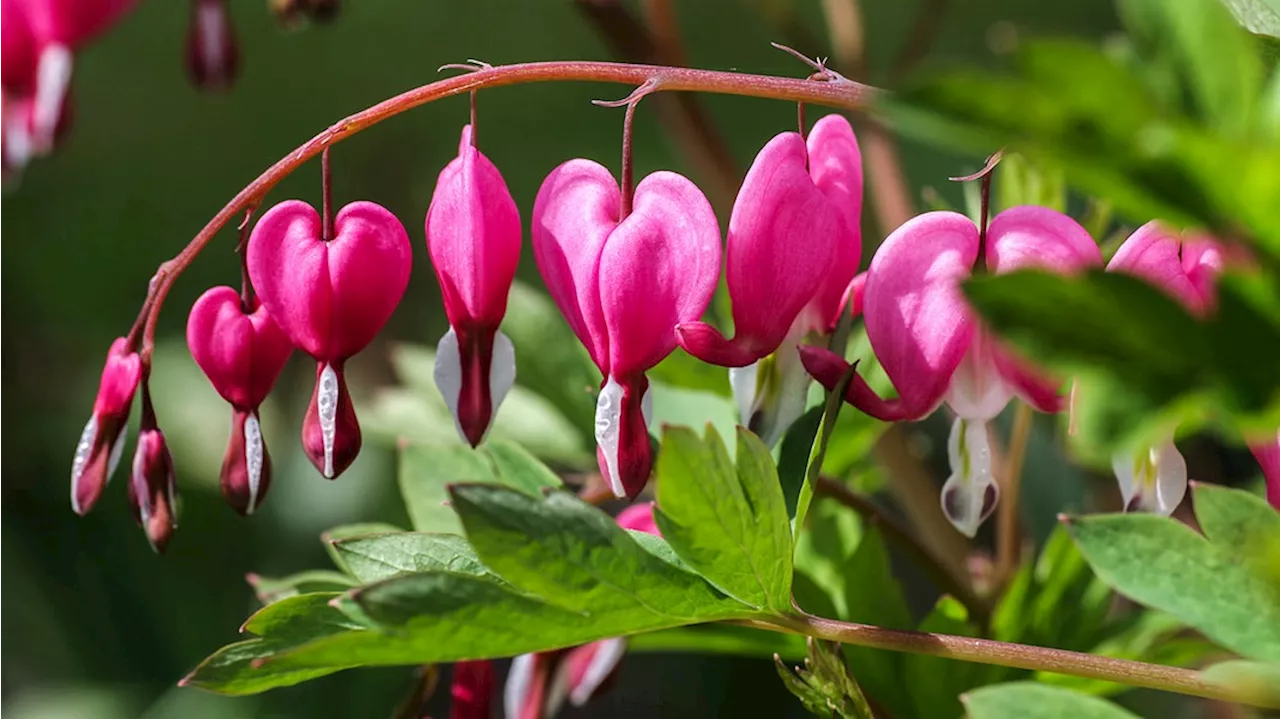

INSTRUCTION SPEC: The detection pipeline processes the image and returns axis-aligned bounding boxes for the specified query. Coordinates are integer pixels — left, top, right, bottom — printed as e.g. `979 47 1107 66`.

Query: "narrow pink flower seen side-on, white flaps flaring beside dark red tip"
426 125 520 446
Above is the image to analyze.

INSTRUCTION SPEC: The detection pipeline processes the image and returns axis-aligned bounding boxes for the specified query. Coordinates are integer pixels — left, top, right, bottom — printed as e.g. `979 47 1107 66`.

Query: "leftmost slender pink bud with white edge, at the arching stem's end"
72 338 142 514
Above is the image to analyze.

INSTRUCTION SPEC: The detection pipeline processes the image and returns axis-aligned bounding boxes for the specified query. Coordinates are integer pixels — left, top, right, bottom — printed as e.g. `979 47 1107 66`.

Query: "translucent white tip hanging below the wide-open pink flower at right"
942 417 1000 537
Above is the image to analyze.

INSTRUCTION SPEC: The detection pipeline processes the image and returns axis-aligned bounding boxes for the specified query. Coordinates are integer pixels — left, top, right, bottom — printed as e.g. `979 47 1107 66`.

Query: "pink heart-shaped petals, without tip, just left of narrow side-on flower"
248 200 412 363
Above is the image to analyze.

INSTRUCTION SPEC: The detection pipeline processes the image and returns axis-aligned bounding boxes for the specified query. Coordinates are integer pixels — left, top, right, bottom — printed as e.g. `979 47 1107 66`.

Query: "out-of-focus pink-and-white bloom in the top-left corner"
0 0 134 168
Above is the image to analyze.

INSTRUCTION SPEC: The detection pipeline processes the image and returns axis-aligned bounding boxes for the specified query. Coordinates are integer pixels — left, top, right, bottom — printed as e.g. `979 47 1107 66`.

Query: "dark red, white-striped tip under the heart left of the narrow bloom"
302 362 360 480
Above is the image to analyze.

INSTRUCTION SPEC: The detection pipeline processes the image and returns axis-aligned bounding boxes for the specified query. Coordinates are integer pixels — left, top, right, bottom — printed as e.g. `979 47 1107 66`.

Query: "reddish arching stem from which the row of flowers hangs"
141 60 881 362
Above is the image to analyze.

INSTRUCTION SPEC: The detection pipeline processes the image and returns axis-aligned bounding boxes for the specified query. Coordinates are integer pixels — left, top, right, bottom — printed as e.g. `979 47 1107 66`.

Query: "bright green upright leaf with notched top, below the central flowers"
654 426 791 612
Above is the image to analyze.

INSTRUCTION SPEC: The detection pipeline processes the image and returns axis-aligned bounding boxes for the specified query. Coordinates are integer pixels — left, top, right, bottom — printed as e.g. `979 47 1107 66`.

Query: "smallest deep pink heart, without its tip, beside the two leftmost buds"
187 287 293 411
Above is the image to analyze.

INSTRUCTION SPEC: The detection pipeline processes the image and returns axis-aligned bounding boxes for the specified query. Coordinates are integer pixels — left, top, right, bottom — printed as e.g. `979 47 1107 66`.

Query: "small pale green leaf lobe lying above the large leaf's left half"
333 532 490 585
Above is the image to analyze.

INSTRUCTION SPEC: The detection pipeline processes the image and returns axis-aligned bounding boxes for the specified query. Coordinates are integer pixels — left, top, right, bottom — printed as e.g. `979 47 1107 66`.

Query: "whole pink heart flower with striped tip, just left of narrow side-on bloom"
247 200 412 478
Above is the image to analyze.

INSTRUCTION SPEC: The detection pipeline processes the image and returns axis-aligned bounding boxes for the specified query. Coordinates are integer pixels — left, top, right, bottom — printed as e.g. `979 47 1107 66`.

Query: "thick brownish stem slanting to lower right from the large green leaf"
751 614 1280 709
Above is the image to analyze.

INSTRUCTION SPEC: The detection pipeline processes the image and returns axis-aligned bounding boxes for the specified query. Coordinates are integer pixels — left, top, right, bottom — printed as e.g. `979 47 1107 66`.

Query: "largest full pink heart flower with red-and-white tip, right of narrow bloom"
532 160 721 498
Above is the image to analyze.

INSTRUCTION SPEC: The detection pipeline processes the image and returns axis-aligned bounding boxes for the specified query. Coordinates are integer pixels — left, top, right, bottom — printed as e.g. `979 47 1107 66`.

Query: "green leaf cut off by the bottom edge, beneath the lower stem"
964 682 1139 719
